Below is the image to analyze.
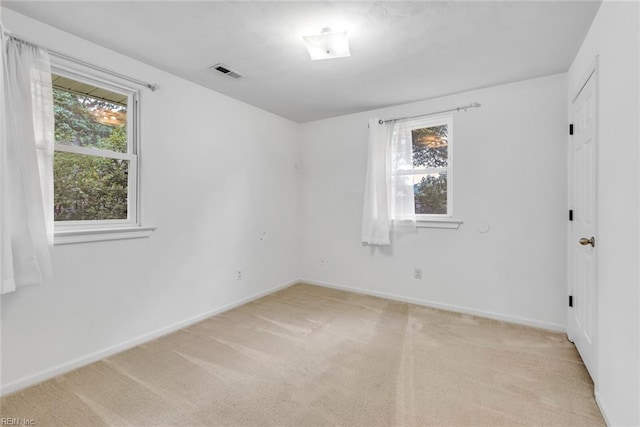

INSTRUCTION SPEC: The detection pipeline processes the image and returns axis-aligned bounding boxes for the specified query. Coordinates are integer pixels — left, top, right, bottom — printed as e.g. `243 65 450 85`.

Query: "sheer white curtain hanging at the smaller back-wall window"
362 118 416 245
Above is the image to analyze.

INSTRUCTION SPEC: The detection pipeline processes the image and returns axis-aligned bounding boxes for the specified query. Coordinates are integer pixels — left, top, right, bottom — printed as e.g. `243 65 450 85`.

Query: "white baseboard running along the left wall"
0 280 300 396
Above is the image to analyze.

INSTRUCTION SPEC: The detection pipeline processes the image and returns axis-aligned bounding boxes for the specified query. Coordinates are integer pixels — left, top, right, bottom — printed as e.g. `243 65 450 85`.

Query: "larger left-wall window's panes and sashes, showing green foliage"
52 74 137 225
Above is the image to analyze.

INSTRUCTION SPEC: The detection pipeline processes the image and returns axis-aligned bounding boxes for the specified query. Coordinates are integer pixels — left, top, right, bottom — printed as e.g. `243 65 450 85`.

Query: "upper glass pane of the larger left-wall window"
51 74 128 153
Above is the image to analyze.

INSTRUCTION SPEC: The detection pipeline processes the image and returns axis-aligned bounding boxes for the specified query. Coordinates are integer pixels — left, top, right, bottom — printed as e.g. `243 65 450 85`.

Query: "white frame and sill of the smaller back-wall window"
400 115 462 228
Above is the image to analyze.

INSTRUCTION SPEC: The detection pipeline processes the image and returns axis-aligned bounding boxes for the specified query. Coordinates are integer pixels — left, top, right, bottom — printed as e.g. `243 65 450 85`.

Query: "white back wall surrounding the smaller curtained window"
302 75 568 330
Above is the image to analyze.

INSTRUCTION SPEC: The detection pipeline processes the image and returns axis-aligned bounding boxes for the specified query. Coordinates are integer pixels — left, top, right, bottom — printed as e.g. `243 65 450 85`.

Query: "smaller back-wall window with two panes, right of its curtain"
400 117 453 221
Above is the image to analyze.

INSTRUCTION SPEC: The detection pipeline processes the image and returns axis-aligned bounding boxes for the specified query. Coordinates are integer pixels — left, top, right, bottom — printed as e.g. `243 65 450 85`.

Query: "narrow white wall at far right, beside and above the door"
568 1 640 425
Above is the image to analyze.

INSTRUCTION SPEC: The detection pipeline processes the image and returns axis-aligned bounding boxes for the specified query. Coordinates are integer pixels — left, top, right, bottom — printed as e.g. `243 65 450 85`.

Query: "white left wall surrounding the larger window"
2 10 299 392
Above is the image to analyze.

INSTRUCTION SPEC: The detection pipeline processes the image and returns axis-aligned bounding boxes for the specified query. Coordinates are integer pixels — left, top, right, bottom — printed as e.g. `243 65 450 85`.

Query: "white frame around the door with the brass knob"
567 55 600 392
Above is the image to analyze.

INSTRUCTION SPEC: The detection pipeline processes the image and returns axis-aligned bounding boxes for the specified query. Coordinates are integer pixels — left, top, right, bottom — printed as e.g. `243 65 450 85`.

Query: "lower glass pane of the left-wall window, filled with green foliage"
53 152 129 221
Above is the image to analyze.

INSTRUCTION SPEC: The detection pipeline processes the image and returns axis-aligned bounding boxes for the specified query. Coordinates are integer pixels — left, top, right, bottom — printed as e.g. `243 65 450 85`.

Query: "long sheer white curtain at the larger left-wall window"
0 38 54 293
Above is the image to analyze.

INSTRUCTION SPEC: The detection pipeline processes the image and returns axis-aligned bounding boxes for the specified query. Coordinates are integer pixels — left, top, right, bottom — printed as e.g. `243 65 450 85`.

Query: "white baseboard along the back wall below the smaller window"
300 279 567 333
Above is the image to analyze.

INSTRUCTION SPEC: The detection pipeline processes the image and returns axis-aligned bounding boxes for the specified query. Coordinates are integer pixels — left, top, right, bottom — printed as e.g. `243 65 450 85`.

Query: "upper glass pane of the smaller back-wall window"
411 125 449 168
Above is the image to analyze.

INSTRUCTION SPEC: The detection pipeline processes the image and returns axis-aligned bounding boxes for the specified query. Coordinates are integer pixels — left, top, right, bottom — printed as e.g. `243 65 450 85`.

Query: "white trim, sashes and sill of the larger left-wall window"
51 58 155 245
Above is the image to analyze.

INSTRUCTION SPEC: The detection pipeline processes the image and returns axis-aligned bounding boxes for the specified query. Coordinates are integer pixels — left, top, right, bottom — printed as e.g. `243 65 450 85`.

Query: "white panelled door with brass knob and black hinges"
568 68 598 382
